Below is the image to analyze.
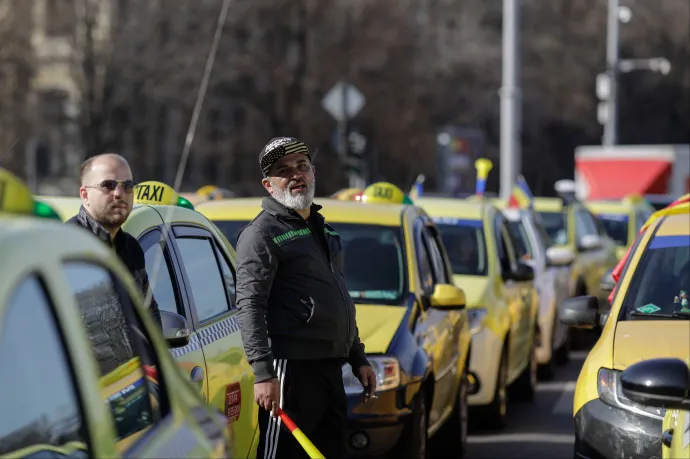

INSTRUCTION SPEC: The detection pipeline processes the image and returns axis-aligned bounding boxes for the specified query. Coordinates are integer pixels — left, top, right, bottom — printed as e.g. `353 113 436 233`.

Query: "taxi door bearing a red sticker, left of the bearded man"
171 223 258 457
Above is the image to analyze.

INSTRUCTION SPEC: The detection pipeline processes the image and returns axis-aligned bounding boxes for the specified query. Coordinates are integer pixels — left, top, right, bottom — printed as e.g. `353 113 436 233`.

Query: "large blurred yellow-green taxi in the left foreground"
0 169 231 458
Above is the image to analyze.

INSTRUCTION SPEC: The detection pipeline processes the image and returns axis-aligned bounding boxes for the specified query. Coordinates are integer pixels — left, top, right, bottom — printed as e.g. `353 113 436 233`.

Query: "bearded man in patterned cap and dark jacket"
236 137 376 459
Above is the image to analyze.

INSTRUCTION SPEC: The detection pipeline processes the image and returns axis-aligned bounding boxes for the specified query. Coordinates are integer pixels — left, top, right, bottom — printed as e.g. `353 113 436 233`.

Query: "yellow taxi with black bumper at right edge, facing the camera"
561 213 690 458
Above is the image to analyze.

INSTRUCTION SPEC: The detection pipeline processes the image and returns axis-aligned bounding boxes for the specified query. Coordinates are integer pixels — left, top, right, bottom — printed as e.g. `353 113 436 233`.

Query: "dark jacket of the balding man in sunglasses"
67 206 163 329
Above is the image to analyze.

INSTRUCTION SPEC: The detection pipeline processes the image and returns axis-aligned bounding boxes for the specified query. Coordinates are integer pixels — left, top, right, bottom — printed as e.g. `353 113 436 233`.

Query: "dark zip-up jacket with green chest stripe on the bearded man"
236 198 369 382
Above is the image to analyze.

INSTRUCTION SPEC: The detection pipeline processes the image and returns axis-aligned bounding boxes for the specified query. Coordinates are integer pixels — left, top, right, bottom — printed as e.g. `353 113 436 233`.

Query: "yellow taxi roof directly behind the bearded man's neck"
197 198 404 226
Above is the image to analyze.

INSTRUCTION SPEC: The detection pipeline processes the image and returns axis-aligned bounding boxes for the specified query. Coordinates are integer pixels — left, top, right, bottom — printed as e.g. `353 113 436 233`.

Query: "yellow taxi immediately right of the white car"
534 197 618 306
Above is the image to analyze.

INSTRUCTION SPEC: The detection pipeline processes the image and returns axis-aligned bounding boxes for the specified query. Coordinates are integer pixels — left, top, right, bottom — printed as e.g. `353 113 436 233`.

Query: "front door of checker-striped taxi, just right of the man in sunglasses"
138 225 208 400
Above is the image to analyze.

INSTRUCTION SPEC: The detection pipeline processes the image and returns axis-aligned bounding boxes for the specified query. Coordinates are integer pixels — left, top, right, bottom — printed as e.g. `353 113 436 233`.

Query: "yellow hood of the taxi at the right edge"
613 320 690 370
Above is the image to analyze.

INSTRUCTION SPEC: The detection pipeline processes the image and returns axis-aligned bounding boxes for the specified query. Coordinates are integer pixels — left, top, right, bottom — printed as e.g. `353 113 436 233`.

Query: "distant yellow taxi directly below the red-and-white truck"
585 195 655 259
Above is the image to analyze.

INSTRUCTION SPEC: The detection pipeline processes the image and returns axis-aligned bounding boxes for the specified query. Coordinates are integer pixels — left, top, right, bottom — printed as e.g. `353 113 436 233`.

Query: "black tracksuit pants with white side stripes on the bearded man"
256 359 347 459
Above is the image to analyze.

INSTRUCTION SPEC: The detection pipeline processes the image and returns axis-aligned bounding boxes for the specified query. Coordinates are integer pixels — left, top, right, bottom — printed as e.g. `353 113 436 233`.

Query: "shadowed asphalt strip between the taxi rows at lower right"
456 351 587 459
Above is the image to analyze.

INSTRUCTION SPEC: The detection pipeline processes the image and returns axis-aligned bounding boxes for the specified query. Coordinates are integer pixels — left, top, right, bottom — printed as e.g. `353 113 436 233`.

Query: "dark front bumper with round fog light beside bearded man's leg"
346 388 413 458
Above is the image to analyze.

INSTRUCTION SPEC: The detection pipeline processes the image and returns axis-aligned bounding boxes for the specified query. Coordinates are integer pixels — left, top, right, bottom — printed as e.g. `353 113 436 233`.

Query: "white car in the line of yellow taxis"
503 208 575 378
